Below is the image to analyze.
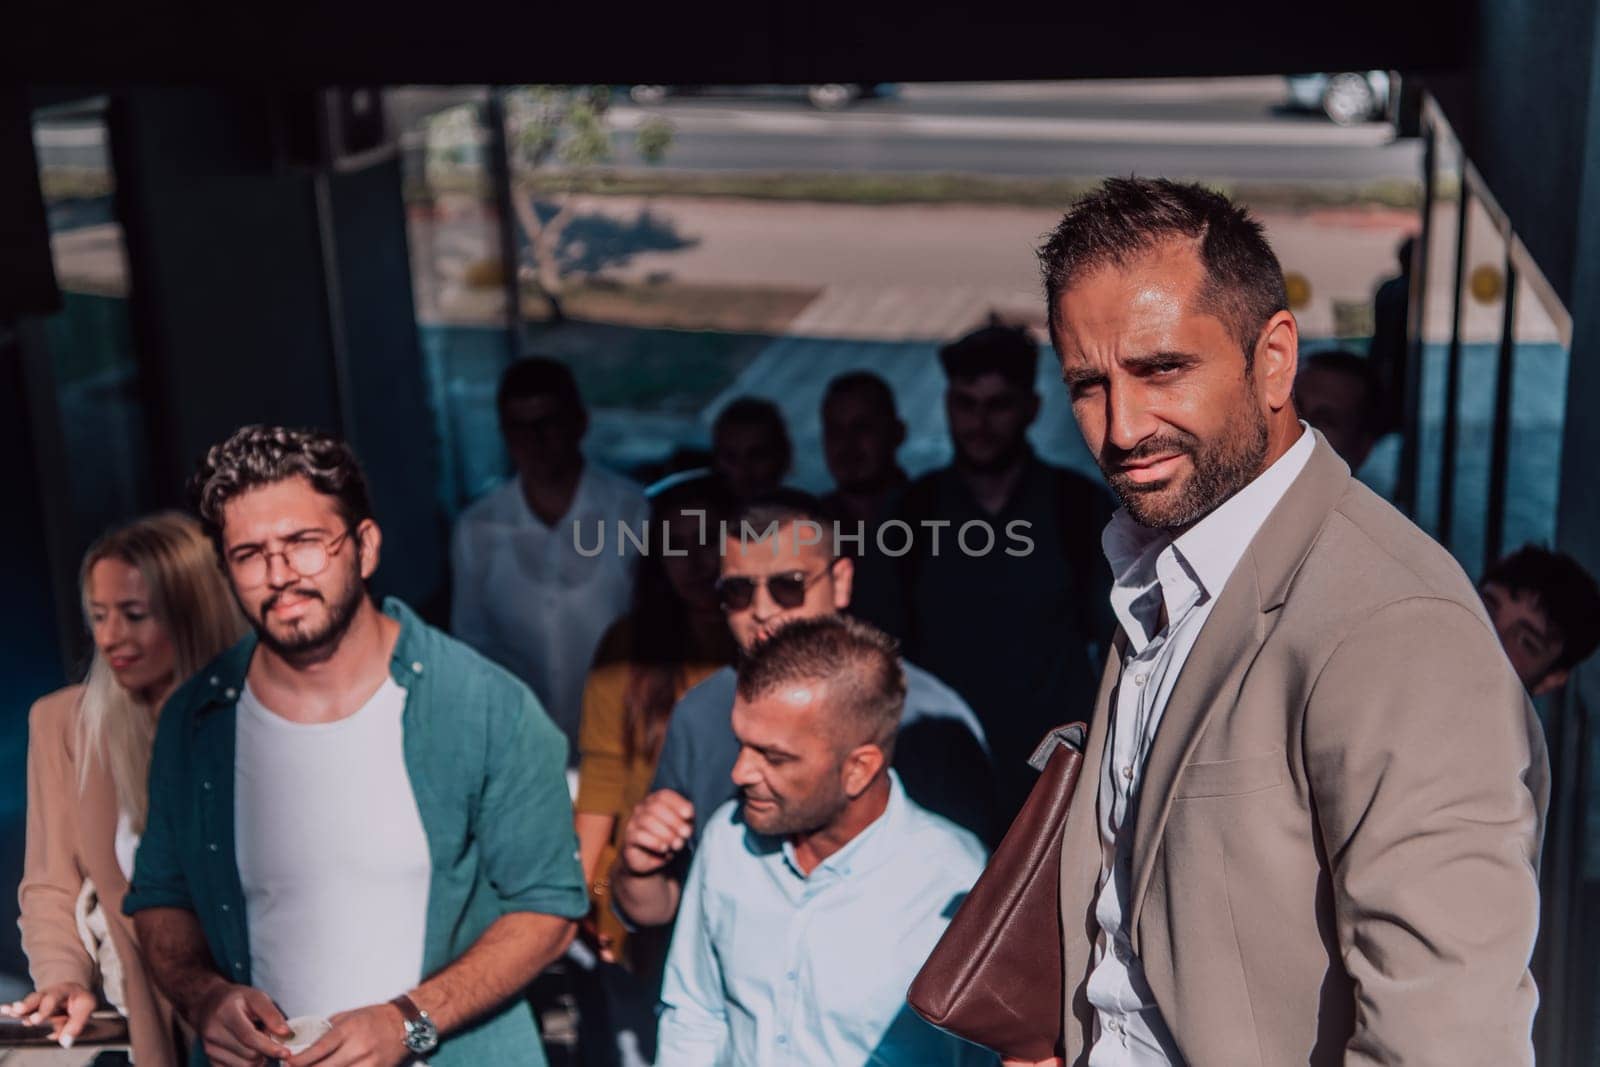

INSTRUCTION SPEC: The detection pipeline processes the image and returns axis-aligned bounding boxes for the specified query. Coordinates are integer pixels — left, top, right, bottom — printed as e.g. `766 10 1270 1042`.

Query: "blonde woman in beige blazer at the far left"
5 514 243 1067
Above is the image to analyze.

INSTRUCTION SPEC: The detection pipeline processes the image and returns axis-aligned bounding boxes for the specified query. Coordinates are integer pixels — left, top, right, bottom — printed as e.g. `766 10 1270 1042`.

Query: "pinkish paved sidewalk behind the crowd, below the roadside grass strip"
521 197 1416 341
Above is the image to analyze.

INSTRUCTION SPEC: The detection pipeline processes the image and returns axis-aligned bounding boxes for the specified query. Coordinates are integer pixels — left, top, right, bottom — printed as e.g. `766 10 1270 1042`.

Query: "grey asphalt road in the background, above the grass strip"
613 78 1421 181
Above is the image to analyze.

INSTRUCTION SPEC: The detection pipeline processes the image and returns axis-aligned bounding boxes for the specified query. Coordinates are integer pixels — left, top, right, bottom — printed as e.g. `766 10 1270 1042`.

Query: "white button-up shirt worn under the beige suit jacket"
1088 422 1317 1067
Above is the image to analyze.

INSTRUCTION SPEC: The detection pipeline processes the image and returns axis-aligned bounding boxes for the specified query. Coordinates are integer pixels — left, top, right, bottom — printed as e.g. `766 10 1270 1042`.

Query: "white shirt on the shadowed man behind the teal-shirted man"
450 461 650 758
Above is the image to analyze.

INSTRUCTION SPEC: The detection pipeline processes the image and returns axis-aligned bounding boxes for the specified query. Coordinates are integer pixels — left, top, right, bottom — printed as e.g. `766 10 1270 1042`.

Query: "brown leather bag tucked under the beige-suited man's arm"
906 723 1088 1061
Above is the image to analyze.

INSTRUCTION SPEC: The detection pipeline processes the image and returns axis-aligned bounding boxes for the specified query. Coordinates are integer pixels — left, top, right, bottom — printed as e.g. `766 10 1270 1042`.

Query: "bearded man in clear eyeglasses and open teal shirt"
125 427 589 1067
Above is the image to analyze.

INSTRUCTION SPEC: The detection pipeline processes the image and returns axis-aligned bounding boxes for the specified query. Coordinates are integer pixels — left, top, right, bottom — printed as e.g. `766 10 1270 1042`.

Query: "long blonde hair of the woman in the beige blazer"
78 512 245 833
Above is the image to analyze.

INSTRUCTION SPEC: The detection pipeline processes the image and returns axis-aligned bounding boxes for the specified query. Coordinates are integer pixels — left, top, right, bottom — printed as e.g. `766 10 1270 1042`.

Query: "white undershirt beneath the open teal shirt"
234 677 432 1019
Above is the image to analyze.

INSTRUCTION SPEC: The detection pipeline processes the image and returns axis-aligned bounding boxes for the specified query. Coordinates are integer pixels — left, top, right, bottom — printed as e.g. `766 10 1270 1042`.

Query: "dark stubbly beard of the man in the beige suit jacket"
1101 395 1267 530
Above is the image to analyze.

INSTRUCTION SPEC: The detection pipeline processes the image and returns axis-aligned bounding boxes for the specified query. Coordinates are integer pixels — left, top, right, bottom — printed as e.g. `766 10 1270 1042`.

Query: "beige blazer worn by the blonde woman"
18 686 179 1067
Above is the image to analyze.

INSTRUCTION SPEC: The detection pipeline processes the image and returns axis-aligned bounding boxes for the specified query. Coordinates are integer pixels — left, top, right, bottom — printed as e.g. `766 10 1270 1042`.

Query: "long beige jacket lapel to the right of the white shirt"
1128 430 1350 952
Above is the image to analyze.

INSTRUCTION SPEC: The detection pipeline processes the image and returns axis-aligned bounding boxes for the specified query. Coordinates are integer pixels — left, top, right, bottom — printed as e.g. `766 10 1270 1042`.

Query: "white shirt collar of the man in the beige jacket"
1101 421 1317 653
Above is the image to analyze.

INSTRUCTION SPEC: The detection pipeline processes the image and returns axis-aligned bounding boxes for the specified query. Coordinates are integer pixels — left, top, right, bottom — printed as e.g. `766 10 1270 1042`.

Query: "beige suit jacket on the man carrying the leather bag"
1061 438 1547 1067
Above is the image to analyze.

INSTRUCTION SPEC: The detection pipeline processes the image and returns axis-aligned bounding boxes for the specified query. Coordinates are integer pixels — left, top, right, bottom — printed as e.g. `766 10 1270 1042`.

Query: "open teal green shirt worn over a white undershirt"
123 600 589 1067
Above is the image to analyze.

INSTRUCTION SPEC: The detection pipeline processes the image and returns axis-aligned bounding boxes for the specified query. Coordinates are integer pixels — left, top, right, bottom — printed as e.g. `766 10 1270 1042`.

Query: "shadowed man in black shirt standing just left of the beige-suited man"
859 320 1115 829
